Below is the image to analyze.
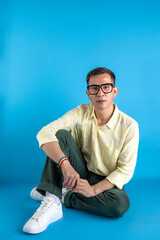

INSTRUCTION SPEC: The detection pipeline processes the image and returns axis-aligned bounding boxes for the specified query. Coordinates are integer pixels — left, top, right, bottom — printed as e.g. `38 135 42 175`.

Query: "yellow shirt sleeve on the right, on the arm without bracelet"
106 122 139 189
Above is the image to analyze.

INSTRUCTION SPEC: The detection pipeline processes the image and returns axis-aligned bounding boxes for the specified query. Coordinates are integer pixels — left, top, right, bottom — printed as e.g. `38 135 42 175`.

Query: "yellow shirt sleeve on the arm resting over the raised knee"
37 107 79 148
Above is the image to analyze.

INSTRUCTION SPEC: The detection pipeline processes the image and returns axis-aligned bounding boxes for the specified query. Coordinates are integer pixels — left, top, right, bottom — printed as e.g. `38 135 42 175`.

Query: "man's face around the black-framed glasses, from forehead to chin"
86 73 118 110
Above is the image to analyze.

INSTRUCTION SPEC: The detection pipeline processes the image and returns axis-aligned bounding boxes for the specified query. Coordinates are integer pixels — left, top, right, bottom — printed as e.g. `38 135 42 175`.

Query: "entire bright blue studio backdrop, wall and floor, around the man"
0 0 160 240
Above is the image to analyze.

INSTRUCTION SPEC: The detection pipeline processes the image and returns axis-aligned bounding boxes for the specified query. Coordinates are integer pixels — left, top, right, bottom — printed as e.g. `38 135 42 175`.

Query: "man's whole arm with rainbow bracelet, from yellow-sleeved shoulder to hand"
37 108 79 189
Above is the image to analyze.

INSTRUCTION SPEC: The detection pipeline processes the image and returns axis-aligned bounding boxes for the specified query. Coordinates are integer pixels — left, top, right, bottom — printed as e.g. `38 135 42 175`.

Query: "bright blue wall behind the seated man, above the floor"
0 0 160 186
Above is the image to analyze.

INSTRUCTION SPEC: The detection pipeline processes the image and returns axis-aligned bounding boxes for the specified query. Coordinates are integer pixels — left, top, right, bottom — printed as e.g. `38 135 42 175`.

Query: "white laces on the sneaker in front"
32 197 53 220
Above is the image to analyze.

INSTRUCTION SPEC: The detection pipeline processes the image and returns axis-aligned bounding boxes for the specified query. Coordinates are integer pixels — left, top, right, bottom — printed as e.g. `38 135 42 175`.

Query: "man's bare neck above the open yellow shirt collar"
95 104 115 126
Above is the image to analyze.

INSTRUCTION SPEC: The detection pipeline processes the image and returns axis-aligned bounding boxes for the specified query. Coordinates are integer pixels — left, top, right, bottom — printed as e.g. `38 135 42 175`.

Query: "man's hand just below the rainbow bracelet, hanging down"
61 161 80 190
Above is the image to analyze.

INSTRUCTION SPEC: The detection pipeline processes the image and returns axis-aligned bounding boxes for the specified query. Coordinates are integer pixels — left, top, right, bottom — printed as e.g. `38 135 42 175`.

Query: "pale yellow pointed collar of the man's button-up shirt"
89 104 119 129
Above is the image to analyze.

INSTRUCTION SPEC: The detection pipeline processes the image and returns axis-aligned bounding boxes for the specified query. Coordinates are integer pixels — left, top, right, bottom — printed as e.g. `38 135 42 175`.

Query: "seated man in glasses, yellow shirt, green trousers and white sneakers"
23 68 139 234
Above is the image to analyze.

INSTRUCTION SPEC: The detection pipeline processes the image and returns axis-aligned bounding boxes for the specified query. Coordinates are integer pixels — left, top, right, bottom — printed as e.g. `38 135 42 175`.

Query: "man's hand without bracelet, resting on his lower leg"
72 178 96 197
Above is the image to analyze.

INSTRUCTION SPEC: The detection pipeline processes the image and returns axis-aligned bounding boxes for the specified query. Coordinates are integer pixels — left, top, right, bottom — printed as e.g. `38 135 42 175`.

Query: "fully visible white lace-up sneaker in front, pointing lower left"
23 197 63 234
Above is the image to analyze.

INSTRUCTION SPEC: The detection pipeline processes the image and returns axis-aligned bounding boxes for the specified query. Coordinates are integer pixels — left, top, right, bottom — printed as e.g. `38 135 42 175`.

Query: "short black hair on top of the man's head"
86 67 116 85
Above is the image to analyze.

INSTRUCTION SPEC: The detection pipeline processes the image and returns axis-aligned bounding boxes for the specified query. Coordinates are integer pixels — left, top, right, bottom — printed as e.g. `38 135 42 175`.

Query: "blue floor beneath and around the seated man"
0 180 160 240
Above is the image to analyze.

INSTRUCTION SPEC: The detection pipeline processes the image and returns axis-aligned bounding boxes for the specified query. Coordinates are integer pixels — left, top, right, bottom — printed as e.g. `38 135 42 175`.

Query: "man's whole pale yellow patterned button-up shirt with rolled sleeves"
37 103 139 189
